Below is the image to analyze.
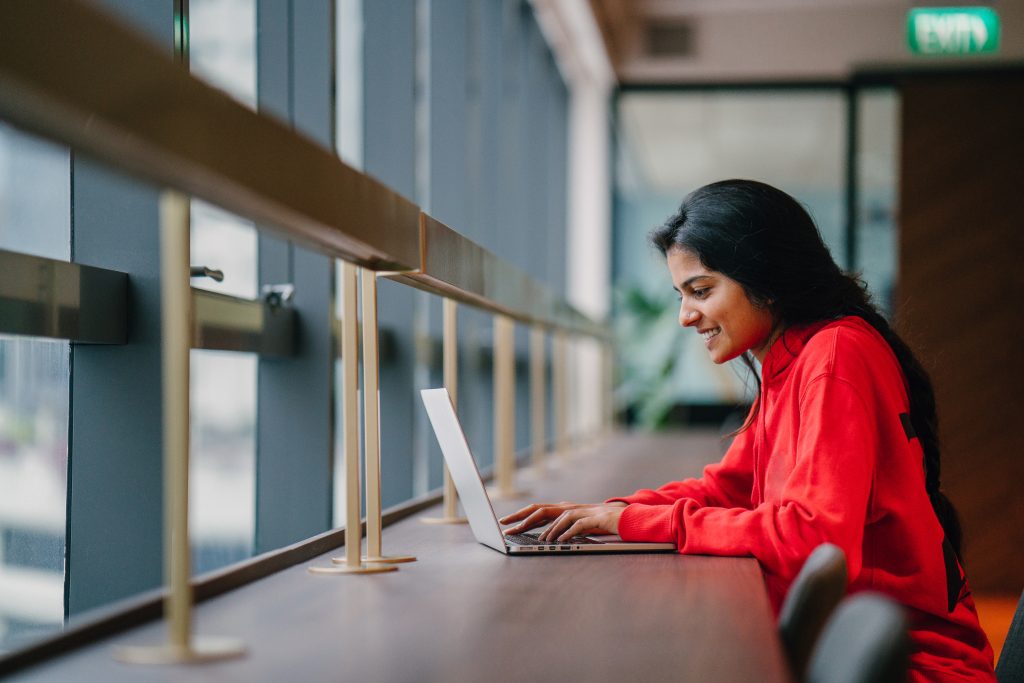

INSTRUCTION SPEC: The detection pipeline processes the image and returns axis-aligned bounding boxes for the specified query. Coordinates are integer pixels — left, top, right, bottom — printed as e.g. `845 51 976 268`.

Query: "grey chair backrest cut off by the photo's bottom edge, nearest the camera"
806 593 910 683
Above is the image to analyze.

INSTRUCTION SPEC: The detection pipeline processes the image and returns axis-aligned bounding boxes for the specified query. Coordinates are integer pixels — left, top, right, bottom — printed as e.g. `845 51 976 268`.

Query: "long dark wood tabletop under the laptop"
9 435 786 682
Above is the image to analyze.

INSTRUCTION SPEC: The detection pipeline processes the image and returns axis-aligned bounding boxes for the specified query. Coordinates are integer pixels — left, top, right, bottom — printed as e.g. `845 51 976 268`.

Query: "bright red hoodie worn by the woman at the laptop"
612 316 995 681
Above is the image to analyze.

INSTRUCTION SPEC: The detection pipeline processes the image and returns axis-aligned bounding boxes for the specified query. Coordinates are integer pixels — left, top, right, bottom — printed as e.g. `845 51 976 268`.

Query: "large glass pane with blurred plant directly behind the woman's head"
612 90 846 411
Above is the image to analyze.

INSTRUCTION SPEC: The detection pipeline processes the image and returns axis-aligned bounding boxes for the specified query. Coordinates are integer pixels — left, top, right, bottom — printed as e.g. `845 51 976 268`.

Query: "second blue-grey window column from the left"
255 0 334 553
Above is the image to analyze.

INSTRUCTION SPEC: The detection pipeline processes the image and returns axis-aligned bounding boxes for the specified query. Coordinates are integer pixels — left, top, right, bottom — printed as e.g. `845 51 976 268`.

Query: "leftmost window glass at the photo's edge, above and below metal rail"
0 124 71 653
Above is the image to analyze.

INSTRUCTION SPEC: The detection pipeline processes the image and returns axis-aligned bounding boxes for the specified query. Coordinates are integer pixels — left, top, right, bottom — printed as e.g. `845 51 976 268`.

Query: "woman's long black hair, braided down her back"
650 180 962 556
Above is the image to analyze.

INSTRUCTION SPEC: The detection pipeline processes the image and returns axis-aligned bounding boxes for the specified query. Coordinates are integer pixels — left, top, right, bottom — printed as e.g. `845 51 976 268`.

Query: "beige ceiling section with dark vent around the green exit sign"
589 0 1024 85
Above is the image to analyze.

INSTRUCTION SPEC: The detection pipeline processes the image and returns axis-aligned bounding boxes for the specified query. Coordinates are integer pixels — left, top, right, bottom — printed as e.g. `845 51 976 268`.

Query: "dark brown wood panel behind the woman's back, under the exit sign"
898 71 1024 594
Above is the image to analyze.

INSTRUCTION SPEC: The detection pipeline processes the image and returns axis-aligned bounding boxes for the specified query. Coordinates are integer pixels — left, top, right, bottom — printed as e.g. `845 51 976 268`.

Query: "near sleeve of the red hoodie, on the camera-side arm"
618 375 878 580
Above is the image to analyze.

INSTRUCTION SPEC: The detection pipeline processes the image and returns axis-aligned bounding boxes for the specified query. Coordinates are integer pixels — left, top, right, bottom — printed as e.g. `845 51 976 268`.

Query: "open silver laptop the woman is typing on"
420 388 676 555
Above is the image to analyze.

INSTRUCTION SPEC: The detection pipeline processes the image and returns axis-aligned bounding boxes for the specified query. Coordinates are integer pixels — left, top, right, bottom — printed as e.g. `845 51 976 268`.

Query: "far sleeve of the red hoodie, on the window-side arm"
606 409 754 508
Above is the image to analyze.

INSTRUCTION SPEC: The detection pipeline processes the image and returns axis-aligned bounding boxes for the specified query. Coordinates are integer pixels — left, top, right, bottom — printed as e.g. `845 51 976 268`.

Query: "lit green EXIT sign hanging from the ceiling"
906 7 999 54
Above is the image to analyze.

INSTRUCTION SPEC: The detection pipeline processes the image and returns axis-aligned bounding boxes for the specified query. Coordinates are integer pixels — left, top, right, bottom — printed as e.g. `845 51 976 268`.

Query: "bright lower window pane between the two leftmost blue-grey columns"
188 350 257 573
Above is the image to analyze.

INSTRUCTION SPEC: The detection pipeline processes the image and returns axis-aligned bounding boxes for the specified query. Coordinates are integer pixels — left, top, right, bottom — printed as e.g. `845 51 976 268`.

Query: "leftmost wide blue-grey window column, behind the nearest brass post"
66 0 174 614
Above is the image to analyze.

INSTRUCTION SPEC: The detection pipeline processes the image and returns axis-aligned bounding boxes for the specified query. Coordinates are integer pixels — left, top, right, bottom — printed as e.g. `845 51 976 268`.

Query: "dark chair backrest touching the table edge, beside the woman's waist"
778 543 846 681
